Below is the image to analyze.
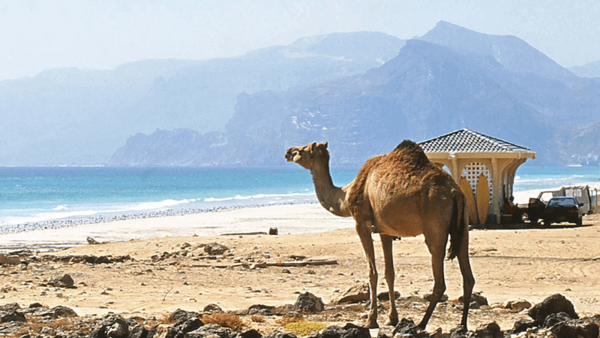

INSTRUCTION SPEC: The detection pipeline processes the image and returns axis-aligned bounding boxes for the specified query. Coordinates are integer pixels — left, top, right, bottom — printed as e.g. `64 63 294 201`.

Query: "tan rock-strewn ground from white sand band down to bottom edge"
0 211 600 338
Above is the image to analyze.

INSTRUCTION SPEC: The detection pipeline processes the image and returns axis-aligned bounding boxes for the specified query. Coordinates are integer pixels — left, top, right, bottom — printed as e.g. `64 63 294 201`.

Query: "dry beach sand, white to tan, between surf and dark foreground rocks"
0 204 600 330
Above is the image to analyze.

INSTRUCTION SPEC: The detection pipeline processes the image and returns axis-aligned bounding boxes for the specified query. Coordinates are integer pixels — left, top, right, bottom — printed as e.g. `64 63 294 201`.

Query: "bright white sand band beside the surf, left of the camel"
0 203 354 253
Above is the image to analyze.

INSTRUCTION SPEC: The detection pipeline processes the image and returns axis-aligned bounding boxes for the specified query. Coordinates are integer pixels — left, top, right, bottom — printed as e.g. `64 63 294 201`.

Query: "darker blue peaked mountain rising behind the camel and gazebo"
111 22 600 166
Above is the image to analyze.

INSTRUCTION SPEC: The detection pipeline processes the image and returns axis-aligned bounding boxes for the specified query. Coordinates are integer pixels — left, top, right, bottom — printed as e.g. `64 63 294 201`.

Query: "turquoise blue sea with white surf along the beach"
0 165 600 234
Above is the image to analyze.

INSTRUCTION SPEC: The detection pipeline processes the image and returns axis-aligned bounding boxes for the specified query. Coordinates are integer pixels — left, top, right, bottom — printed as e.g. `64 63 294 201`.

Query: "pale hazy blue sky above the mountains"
0 0 600 81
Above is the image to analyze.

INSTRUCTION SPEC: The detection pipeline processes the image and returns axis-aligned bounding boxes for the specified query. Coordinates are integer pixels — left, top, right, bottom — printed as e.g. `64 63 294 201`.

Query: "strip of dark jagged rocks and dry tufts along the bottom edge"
0 290 600 338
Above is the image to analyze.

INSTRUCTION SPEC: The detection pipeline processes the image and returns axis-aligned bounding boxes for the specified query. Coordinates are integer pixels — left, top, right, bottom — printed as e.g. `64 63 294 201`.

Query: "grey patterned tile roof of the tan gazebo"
419 129 530 153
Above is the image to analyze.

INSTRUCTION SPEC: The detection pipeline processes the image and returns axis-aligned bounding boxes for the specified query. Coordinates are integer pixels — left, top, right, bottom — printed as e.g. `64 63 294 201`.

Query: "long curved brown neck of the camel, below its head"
310 160 352 217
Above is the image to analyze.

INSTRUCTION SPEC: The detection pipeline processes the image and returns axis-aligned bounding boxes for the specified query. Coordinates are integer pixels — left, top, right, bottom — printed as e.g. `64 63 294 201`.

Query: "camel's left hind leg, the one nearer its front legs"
419 236 447 329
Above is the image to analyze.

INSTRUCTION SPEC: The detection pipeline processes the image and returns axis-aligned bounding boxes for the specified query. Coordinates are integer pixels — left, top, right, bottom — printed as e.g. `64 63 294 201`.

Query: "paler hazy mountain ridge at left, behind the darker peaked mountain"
0 32 404 166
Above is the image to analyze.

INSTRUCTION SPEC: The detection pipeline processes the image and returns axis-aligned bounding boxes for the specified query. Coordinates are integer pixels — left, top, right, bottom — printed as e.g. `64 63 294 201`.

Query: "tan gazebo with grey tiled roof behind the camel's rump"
419 129 535 224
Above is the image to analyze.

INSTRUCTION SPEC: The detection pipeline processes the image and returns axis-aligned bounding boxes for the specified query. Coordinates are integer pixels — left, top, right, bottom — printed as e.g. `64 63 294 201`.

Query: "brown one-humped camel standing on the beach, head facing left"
285 141 475 329
